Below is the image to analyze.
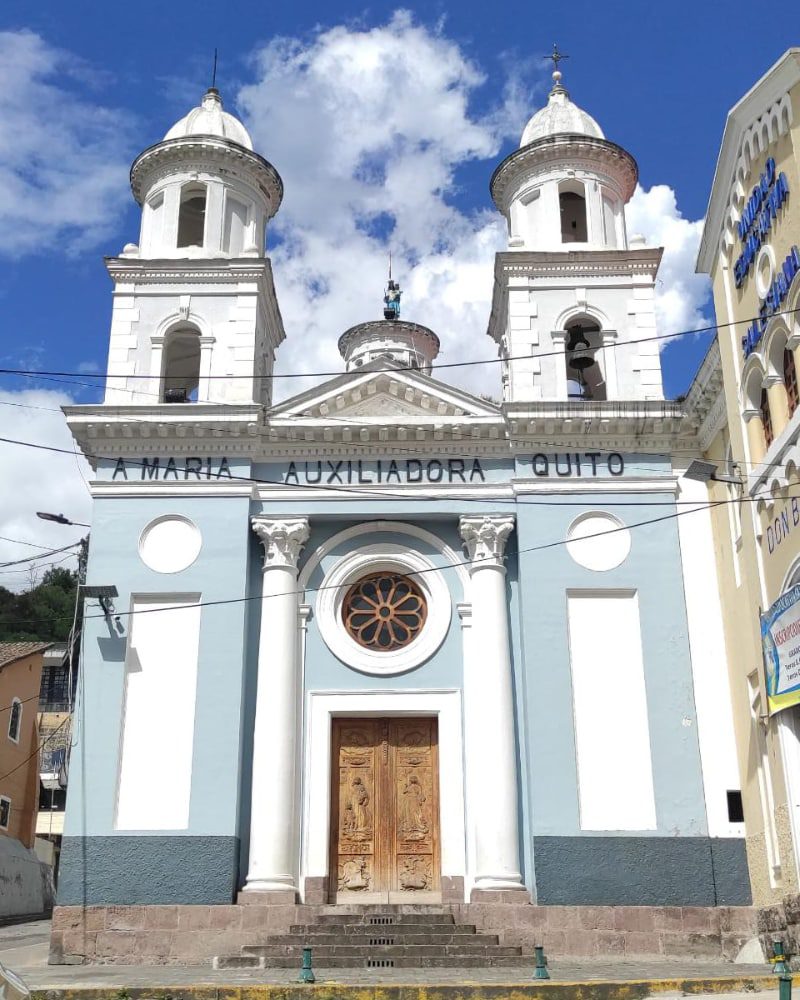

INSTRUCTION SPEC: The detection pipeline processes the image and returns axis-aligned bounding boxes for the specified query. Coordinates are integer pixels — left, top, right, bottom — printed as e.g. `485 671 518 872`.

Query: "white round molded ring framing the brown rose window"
316 544 452 676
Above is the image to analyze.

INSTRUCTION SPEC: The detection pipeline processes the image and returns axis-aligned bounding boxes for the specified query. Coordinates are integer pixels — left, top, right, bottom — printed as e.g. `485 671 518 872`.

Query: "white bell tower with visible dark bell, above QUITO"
488 58 663 402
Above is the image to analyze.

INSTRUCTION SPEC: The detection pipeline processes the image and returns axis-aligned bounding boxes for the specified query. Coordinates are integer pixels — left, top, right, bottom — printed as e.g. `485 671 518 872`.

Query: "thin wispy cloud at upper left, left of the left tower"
0 31 131 255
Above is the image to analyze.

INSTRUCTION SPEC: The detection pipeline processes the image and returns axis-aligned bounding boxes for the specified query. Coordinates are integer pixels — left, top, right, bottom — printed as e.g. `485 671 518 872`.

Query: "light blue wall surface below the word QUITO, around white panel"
515 493 707 836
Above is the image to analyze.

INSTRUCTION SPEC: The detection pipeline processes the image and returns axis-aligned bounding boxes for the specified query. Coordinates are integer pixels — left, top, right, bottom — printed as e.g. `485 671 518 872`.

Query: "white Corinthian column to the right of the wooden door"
459 514 525 891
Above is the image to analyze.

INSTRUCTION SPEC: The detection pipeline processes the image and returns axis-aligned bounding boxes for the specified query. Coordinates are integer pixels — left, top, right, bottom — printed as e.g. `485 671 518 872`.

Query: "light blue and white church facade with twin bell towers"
54 72 750 952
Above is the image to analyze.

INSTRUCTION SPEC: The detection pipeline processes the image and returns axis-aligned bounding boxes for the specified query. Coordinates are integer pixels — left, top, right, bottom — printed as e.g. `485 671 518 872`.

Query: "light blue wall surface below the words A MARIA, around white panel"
65 488 251 837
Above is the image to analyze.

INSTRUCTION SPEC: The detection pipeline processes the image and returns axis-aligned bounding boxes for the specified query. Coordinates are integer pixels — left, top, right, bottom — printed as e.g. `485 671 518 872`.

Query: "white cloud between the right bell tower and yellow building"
626 184 711 345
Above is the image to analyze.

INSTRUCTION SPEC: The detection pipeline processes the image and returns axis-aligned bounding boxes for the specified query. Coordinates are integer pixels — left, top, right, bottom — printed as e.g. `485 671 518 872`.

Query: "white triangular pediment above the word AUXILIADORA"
270 362 500 422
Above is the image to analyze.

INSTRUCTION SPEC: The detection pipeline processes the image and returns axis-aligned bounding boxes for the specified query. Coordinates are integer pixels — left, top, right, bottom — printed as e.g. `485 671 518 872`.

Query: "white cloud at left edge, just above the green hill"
0 389 91 590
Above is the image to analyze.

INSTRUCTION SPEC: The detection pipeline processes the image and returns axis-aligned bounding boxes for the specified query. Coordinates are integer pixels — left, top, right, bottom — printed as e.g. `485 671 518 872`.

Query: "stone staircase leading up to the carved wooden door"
214 906 525 969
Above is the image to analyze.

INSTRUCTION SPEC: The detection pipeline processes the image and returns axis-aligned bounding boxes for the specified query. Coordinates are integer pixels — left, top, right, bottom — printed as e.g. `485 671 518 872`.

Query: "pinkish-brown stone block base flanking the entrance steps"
50 902 756 965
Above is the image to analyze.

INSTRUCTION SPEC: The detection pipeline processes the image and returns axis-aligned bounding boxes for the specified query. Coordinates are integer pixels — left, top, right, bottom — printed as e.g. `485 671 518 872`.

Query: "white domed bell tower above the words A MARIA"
105 87 285 407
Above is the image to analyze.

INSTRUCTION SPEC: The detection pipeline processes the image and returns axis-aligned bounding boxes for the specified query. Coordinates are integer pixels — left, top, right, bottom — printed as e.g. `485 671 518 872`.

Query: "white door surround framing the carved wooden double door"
300 689 470 899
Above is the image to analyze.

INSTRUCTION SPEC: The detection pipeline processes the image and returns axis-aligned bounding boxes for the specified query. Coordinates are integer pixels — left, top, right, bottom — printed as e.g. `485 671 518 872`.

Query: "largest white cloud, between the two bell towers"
238 12 524 397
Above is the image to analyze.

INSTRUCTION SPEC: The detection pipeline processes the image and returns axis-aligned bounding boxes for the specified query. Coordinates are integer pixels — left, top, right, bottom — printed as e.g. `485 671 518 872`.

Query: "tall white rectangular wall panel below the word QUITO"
567 591 656 830
